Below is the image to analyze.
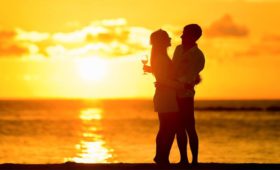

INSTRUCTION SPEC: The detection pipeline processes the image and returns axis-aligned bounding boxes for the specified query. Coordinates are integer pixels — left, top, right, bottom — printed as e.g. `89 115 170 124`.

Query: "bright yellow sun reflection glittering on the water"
66 108 113 163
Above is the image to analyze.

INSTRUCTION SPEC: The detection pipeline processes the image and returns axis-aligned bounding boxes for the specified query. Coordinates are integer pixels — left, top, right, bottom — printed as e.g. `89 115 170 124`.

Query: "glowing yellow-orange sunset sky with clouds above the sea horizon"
0 0 280 99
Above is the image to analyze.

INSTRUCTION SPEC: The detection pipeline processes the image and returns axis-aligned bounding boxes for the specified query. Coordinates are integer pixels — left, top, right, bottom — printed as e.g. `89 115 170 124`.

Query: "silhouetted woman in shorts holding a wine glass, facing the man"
150 30 187 164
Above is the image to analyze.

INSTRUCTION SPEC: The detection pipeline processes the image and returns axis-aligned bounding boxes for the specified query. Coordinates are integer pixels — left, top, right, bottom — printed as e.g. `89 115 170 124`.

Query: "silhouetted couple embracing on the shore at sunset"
143 24 205 165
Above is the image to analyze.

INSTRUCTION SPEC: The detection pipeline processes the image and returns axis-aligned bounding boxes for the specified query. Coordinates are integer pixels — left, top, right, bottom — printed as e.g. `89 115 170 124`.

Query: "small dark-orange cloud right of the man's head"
204 15 249 38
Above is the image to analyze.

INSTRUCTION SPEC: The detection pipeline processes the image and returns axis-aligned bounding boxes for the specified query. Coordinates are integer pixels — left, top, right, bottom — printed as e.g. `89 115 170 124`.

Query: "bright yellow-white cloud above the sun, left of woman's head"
47 19 150 57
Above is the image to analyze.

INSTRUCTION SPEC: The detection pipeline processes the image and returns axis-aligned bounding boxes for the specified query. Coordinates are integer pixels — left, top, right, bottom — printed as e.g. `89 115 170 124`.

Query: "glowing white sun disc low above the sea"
76 58 107 81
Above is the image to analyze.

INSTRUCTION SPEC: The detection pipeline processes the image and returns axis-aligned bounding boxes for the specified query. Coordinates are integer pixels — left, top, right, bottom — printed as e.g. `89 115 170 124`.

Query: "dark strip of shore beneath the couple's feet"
0 162 280 170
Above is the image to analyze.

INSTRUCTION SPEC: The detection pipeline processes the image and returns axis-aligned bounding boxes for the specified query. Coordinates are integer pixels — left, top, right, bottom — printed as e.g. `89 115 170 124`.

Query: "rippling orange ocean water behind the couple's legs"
0 100 280 163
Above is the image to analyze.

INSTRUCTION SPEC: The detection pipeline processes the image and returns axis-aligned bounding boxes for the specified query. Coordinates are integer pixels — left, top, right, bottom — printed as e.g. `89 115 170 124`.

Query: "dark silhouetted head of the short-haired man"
181 24 202 45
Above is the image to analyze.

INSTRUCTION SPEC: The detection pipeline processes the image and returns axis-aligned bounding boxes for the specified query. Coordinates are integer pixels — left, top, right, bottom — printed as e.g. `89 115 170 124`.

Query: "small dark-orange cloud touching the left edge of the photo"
0 30 29 57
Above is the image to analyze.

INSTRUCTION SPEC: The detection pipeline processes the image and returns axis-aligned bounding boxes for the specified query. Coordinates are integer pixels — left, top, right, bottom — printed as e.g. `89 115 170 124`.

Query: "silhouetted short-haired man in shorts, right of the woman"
172 24 205 165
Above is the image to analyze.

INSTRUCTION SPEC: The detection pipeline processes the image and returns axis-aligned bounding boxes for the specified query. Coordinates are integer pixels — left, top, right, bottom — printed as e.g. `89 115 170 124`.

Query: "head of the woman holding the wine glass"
150 29 171 48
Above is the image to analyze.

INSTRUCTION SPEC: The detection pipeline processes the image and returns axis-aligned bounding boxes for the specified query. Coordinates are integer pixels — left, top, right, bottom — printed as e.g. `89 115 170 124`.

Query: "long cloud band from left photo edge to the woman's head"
0 19 151 58
